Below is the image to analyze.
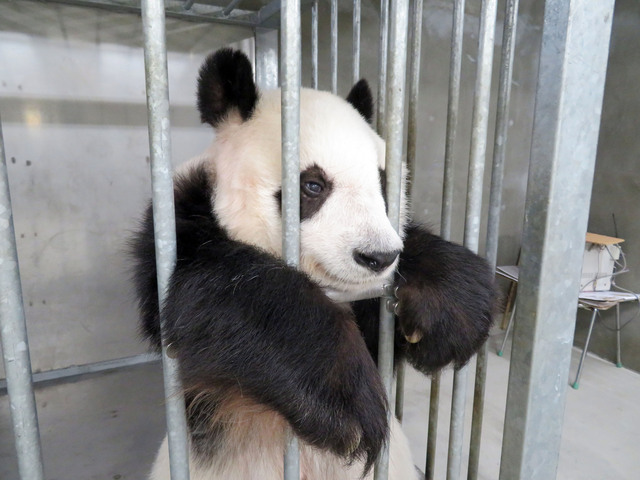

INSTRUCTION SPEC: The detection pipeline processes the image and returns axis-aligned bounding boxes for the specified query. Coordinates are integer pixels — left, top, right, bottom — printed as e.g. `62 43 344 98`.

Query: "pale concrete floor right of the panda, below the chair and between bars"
403 336 640 480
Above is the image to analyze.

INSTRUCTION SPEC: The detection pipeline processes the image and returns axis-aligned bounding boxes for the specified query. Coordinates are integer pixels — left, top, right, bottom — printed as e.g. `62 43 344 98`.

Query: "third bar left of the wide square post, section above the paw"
440 0 465 240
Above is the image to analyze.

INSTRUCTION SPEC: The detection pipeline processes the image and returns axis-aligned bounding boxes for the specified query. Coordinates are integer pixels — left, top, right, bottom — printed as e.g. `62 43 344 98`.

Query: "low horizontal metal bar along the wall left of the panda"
0 353 160 394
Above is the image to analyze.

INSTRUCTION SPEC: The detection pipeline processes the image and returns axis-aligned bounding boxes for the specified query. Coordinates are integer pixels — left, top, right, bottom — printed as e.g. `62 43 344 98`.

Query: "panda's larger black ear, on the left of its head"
198 48 258 127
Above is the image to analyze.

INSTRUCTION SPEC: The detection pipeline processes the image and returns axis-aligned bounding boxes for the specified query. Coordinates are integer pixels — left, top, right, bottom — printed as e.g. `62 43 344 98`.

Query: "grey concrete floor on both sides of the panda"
0 337 640 480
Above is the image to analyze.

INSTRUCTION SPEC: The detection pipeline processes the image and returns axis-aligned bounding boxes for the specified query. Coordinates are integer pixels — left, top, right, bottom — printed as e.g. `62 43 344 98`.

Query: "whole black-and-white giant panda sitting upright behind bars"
132 49 494 480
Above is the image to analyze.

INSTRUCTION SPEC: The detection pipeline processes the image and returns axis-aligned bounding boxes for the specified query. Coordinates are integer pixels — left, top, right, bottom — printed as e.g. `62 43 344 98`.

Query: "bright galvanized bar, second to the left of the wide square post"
447 0 498 480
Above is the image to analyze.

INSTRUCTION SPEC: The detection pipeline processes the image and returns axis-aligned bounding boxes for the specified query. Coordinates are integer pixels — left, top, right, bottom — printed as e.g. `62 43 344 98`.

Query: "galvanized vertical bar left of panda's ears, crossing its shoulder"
142 0 189 480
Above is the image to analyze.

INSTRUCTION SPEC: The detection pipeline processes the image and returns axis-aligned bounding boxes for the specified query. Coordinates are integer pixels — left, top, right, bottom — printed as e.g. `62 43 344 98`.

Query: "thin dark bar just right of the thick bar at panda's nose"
396 0 423 422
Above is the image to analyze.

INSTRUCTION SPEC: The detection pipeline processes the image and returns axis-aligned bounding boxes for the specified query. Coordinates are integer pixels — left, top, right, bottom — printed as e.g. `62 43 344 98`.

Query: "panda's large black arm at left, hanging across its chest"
133 164 387 467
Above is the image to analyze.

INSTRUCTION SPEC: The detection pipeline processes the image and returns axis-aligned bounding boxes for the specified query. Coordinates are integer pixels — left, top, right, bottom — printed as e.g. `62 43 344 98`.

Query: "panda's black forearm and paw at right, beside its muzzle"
353 224 495 374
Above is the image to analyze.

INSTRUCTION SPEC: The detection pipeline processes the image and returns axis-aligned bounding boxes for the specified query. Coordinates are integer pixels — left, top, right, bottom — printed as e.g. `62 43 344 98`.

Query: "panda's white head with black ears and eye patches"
198 49 404 294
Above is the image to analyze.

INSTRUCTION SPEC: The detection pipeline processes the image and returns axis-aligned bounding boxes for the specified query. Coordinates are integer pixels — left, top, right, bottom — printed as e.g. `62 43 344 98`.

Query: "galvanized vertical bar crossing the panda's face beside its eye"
280 0 301 480
